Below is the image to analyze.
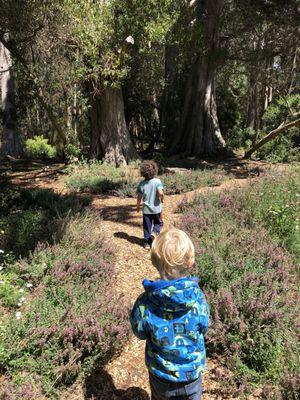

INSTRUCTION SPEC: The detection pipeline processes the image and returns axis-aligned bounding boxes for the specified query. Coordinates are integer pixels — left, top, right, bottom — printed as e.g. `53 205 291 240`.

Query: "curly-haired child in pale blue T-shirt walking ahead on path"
136 160 164 249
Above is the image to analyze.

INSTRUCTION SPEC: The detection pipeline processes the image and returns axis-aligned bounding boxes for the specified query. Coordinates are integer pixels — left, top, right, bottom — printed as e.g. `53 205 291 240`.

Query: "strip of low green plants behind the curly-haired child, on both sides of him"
65 161 229 197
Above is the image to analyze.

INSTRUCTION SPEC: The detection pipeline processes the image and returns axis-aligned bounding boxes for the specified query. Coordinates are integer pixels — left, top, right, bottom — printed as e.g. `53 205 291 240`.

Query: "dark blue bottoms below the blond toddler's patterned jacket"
149 372 202 400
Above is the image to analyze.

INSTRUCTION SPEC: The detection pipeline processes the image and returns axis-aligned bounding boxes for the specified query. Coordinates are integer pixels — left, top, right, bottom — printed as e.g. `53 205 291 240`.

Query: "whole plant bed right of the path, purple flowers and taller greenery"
179 166 300 399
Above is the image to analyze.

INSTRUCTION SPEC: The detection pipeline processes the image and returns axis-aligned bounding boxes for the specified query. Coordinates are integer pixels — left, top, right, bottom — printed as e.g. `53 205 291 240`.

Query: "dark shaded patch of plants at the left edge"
0 177 91 258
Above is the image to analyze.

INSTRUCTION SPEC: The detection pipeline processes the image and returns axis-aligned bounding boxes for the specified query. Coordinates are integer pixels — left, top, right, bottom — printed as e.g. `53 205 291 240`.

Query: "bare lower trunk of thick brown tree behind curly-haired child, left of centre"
91 87 138 166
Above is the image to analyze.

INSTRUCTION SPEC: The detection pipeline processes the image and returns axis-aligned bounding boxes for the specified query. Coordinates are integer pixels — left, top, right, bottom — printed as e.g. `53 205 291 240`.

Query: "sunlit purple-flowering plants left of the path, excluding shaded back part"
0 215 129 399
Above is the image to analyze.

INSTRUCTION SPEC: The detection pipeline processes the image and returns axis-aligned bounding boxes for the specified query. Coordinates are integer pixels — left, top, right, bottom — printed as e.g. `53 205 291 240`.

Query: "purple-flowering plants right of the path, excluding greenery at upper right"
178 178 299 399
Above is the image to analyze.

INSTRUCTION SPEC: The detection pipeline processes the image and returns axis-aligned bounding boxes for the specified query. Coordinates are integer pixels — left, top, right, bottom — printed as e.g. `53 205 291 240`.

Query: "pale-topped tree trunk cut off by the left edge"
0 42 22 157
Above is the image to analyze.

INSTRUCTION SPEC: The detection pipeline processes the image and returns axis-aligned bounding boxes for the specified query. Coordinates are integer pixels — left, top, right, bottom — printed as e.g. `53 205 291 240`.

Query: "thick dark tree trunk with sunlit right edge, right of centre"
171 0 225 156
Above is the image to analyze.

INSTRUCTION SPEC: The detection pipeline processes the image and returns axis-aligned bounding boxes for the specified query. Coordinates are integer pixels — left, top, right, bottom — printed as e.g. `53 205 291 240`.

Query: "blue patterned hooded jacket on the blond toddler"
130 277 209 382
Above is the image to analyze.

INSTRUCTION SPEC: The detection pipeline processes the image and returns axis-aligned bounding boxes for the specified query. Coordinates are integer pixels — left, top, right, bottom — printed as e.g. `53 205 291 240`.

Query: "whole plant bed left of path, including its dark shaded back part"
0 188 129 400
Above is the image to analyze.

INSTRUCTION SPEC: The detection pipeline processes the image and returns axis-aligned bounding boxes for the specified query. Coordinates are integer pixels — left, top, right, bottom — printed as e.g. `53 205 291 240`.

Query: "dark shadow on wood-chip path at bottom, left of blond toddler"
84 370 150 400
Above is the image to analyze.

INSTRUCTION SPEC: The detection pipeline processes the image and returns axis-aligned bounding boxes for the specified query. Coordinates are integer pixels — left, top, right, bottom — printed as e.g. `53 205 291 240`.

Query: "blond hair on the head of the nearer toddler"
151 228 195 279
